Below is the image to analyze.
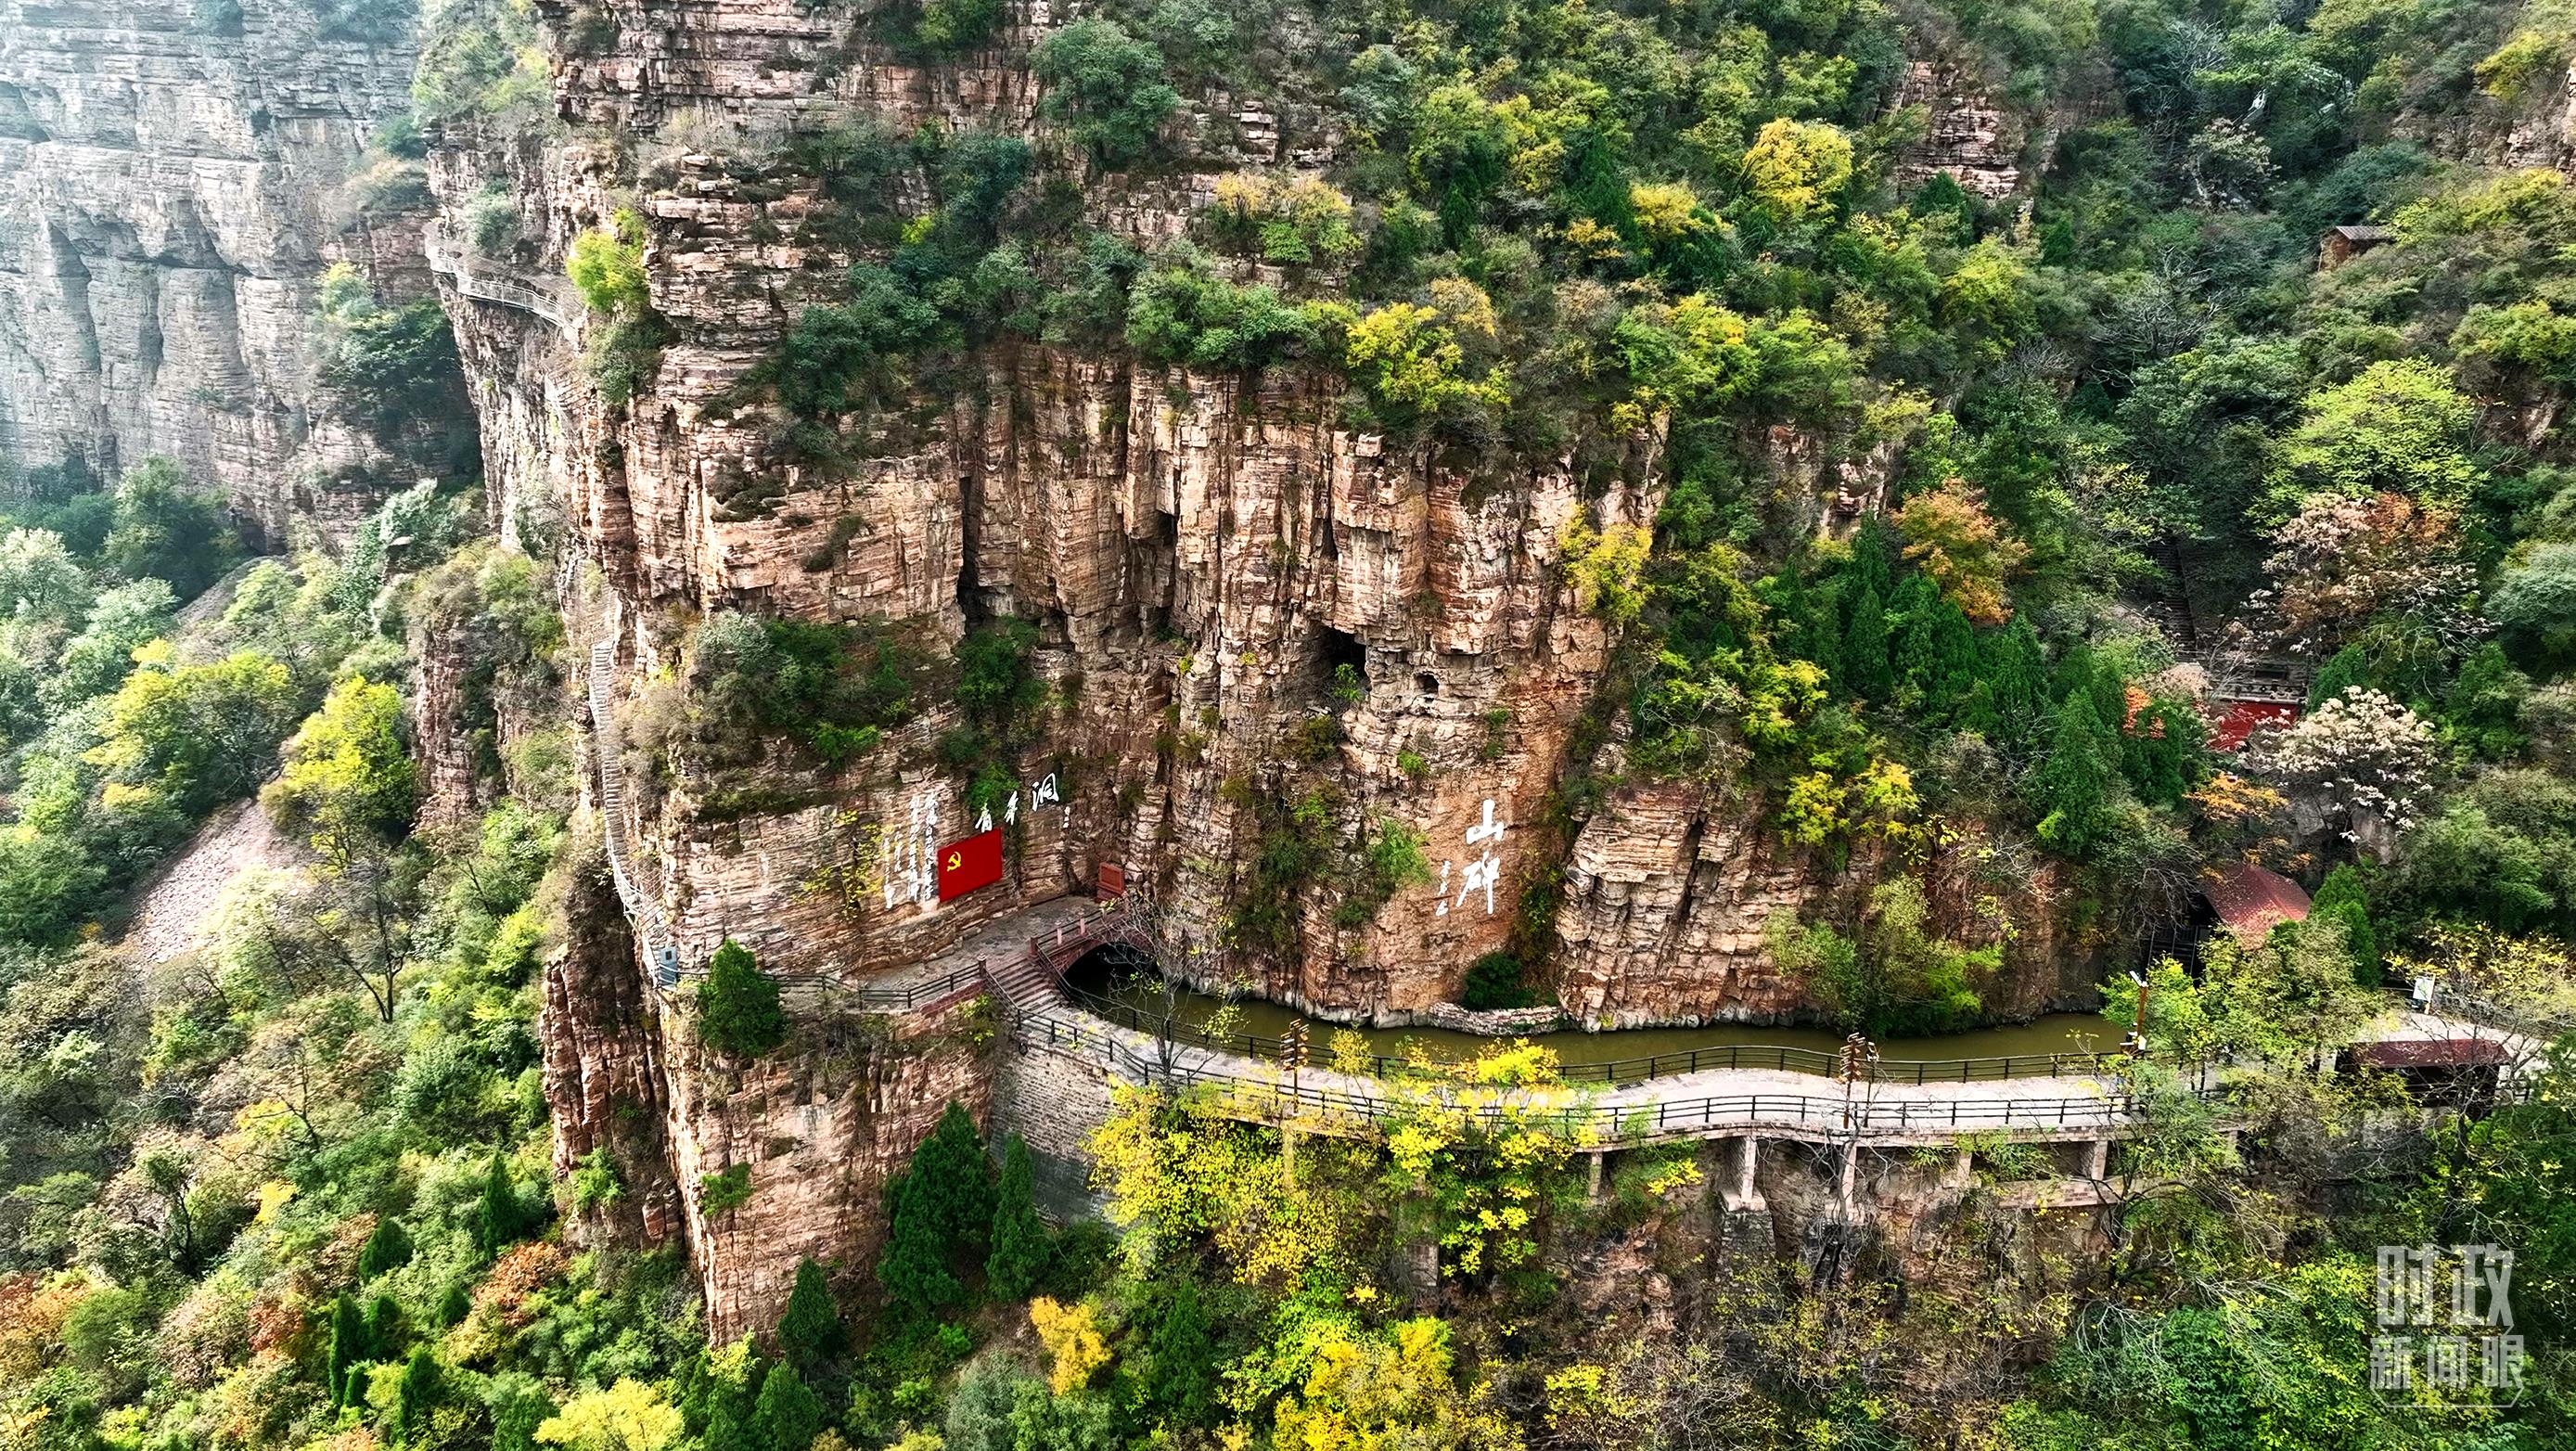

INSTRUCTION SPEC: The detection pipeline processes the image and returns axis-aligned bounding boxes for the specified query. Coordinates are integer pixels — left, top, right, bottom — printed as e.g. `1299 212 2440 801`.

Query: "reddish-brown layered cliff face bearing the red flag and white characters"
433 0 2058 1335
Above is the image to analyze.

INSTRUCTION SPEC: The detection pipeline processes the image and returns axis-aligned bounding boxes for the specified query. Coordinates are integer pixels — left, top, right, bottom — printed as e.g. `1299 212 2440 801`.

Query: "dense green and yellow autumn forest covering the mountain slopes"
0 0 2576 1451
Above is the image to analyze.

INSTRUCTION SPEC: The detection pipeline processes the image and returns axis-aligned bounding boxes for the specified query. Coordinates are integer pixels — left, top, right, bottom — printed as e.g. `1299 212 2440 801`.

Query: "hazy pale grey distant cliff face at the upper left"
0 0 425 533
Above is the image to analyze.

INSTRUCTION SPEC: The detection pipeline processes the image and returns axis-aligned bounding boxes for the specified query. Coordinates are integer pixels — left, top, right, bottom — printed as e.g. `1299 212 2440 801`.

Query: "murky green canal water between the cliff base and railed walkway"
1071 958 2120 1072
